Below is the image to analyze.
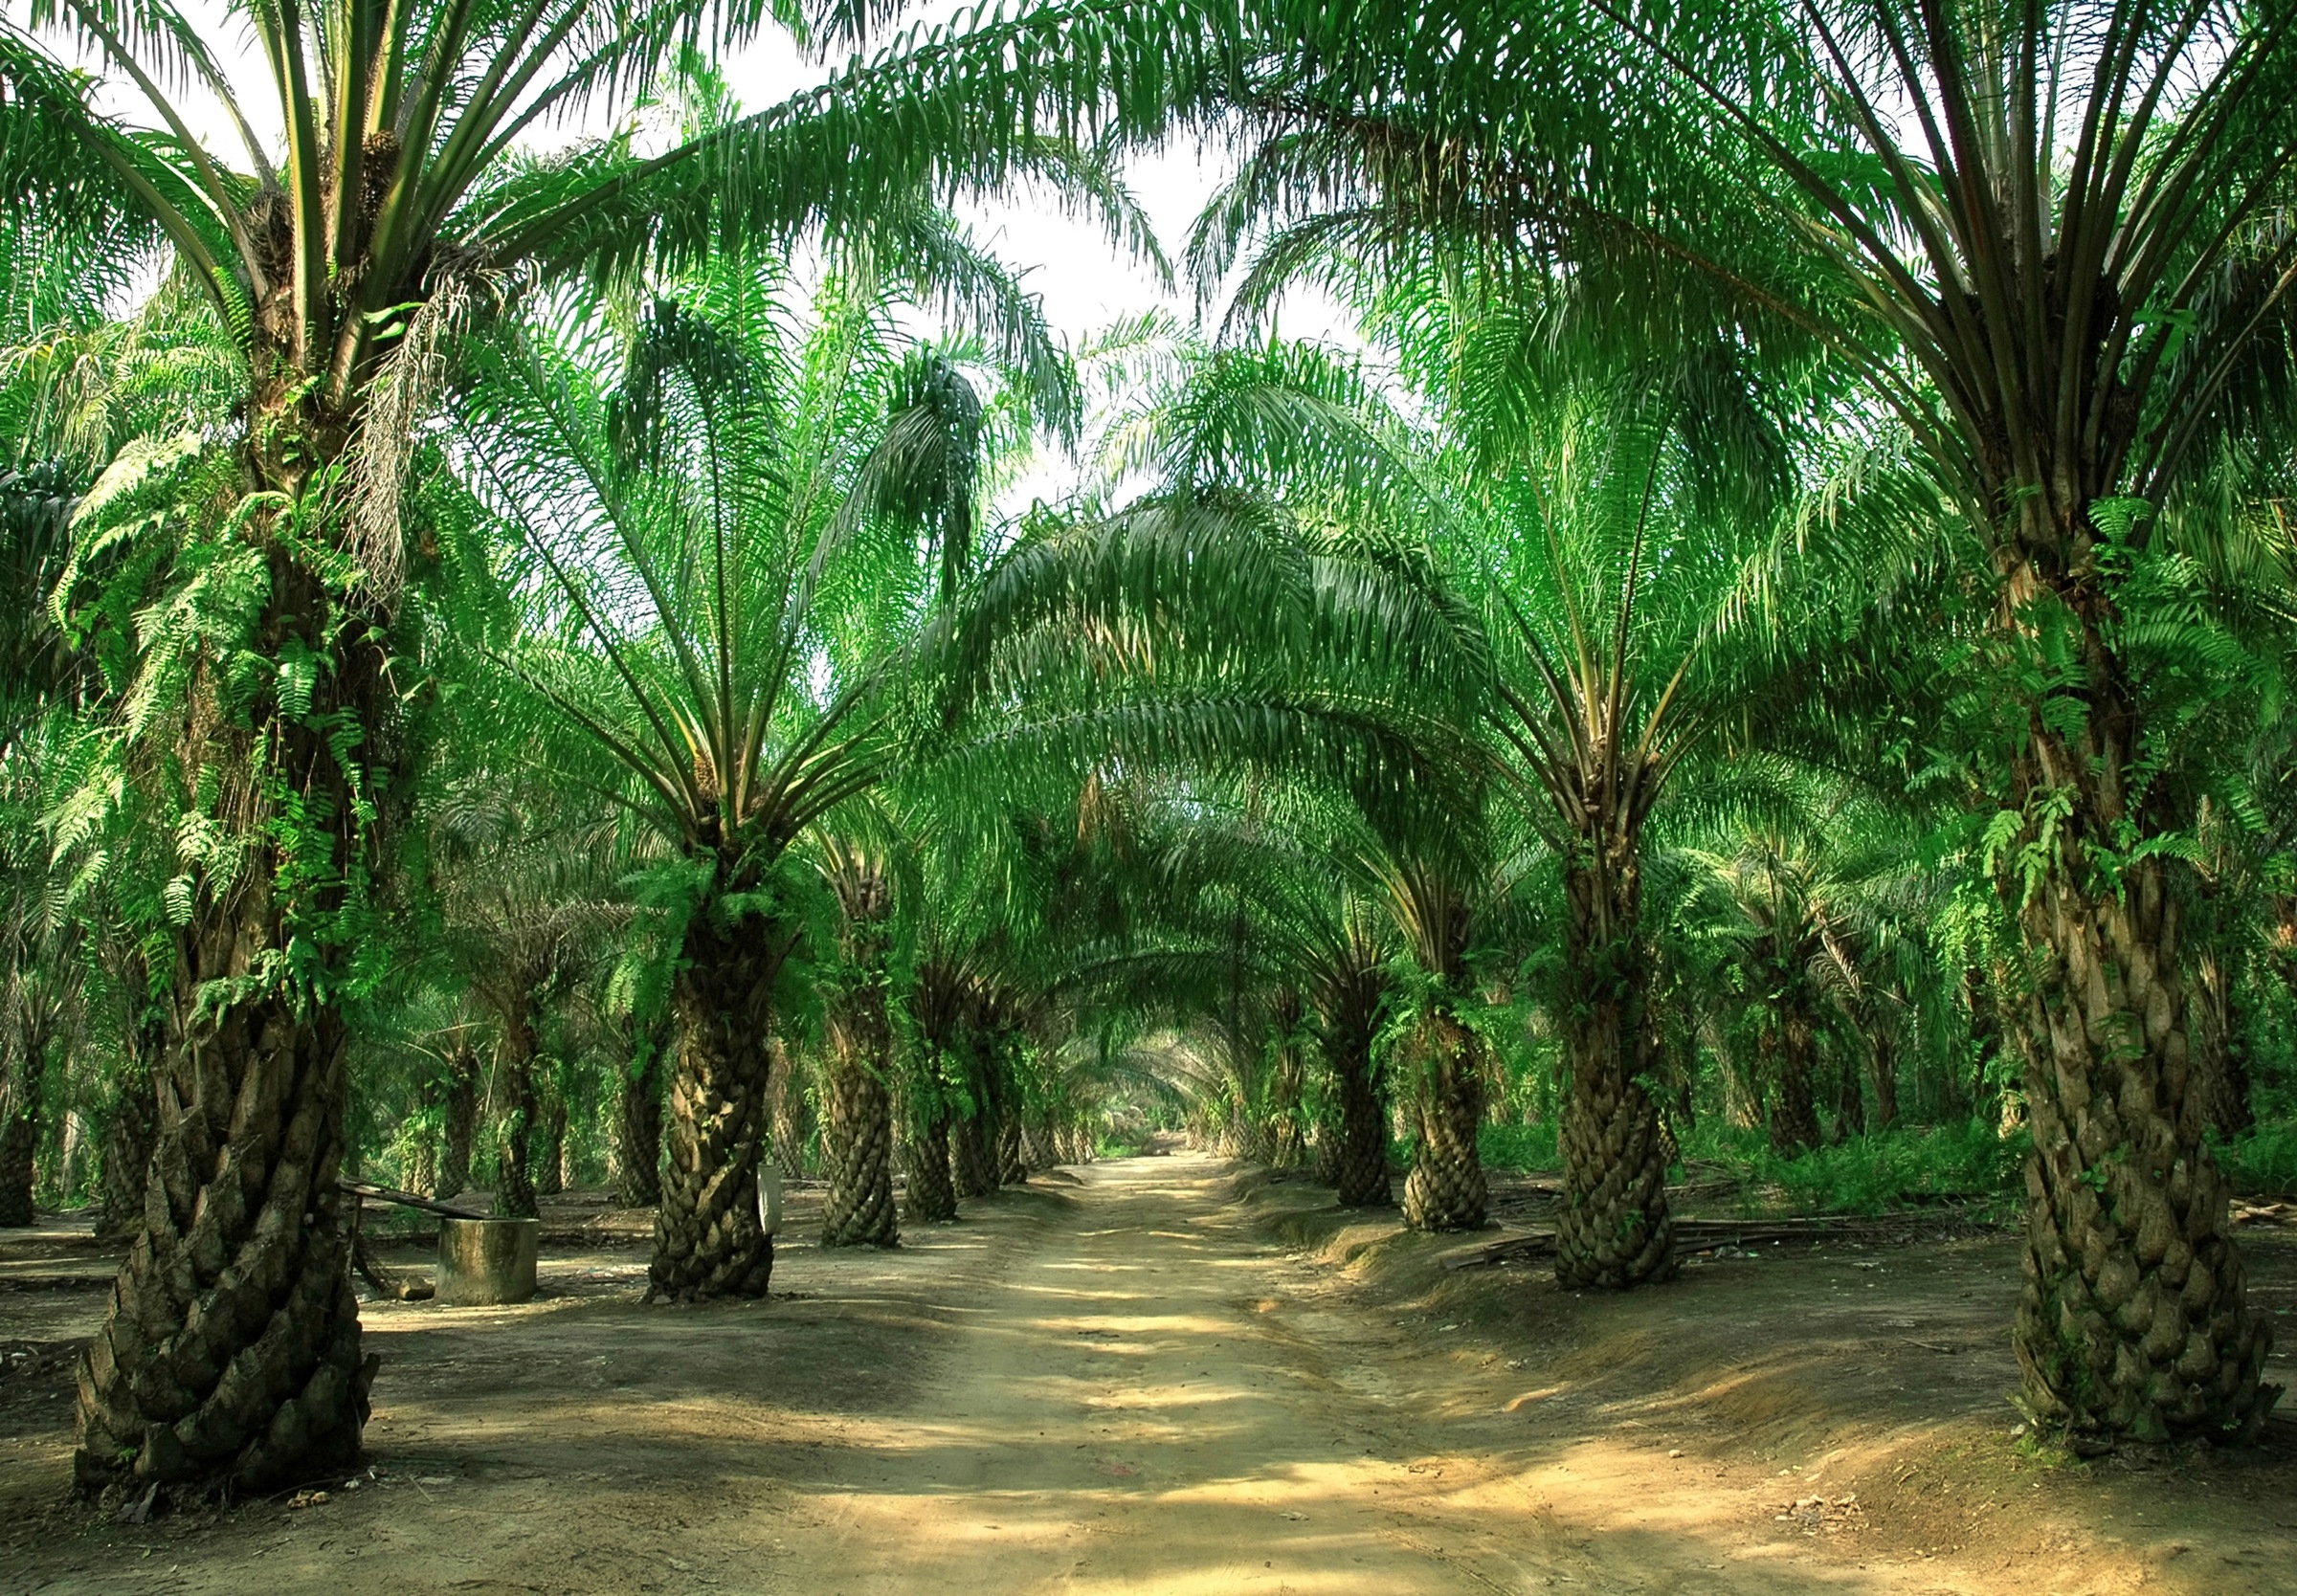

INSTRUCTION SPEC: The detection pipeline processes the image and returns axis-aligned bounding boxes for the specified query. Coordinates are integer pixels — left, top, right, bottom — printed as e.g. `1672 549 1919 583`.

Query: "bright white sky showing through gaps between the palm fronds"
27 0 1360 510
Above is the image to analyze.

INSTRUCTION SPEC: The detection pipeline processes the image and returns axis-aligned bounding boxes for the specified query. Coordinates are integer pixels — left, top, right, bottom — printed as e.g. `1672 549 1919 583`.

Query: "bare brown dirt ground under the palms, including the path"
0 1155 2297 1596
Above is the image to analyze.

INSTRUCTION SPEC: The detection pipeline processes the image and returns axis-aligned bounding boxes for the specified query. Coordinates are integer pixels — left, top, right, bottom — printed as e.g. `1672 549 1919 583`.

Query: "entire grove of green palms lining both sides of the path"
0 0 2297 1488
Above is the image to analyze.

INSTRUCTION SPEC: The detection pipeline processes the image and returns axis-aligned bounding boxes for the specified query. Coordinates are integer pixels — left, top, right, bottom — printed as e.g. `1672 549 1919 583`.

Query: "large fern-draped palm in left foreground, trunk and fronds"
0 0 1142 1488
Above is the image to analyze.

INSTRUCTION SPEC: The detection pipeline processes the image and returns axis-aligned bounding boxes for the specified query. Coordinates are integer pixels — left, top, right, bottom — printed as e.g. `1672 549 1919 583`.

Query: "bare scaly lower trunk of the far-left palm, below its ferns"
74 909 379 1491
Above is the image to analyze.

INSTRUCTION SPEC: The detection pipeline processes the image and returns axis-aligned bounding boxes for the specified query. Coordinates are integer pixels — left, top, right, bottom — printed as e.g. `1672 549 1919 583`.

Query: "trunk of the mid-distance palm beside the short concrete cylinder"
645 909 794 1302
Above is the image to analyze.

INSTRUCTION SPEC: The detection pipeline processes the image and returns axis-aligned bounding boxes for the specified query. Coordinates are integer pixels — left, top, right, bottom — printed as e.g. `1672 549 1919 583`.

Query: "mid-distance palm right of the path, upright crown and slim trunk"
1454 388 1759 1286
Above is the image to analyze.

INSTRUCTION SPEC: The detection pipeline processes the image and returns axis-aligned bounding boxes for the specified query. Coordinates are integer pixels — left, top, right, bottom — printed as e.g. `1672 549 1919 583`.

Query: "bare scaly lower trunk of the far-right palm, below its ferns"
2015 850 2279 1440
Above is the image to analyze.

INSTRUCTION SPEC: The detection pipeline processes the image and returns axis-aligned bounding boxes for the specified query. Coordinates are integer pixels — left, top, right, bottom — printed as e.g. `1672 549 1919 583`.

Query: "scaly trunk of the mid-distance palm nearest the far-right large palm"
1555 843 1675 1291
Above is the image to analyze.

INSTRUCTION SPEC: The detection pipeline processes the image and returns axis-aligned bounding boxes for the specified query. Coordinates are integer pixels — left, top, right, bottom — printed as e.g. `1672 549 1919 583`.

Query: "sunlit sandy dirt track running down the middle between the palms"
791 1158 1975 1596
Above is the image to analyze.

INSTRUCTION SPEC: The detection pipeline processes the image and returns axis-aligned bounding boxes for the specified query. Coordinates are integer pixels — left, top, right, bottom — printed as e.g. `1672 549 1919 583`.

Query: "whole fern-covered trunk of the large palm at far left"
74 277 400 1491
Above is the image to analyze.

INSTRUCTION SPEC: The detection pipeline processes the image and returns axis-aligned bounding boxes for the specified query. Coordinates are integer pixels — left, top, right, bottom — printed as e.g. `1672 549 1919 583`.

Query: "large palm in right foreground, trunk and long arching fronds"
790 0 2297 1437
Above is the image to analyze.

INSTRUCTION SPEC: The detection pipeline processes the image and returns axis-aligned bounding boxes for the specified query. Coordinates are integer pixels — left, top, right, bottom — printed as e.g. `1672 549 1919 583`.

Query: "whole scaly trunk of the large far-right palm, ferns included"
1998 519 2281 1445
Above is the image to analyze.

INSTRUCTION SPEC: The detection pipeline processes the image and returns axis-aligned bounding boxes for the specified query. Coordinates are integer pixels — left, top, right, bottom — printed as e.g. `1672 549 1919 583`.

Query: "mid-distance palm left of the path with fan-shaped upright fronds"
445 253 1034 1297
